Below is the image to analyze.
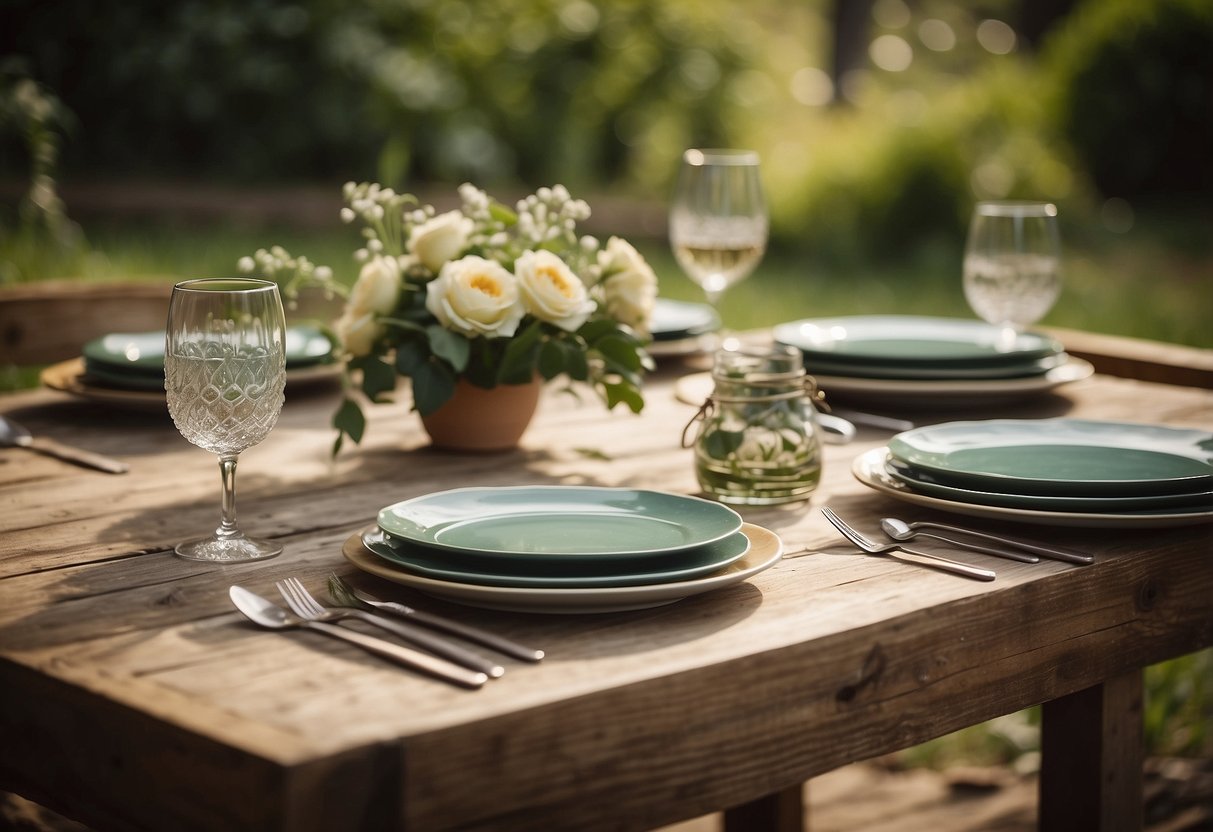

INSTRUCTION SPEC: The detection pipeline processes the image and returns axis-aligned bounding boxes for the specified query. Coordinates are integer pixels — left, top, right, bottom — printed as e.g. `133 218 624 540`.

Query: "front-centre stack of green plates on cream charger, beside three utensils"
344 486 782 612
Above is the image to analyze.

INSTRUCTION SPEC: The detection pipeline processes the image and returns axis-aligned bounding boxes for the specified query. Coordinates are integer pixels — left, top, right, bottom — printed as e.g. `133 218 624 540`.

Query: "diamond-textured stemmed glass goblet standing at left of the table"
164 279 286 562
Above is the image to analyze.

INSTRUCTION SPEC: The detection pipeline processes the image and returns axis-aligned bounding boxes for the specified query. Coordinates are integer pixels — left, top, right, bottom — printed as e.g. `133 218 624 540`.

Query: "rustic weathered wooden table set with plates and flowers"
0 339 1213 830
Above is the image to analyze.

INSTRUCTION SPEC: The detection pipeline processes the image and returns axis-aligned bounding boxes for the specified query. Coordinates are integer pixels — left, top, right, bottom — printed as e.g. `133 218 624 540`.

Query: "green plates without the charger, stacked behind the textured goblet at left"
84 325 334 391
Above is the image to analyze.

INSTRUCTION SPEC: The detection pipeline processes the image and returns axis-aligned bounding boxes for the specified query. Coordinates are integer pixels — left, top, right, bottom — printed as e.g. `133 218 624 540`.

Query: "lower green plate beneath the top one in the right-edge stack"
888 457 1213 513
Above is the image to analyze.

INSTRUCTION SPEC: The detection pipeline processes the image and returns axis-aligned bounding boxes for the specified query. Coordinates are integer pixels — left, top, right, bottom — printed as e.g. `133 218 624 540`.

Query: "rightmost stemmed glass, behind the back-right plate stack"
964 203 1061 348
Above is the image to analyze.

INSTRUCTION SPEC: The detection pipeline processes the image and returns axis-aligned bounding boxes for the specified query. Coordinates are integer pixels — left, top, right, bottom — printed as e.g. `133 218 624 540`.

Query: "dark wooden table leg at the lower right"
1038 671 1144 832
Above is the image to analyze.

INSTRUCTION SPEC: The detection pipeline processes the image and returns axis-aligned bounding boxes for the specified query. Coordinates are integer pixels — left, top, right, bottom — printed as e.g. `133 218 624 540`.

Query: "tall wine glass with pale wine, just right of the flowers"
670 149 768 339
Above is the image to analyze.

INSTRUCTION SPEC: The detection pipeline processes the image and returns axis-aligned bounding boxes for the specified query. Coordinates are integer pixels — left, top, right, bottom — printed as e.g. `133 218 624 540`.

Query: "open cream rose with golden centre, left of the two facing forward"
426 255 525 338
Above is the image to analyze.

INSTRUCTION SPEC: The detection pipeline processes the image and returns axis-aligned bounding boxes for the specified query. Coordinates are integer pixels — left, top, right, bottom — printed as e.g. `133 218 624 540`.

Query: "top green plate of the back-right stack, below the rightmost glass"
774 315 1061 367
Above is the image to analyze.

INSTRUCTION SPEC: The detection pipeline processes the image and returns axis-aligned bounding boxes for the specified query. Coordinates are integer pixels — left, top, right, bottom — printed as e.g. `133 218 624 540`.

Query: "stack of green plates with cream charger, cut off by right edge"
853 418 1213 526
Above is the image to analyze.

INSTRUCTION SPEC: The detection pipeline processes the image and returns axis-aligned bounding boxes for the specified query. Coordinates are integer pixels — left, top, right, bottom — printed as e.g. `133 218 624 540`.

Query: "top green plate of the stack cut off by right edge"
889 418 1213 497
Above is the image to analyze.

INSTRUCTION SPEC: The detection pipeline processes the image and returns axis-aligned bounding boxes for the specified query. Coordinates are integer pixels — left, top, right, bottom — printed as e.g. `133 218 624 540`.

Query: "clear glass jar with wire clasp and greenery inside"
688 346 821 506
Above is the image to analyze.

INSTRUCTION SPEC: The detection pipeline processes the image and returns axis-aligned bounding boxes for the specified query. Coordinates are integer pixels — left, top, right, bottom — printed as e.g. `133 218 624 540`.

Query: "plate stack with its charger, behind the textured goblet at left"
42 324 340 409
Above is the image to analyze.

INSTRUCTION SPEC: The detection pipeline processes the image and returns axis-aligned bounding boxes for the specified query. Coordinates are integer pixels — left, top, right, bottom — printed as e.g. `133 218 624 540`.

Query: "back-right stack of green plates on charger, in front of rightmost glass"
774 315 1093 404
